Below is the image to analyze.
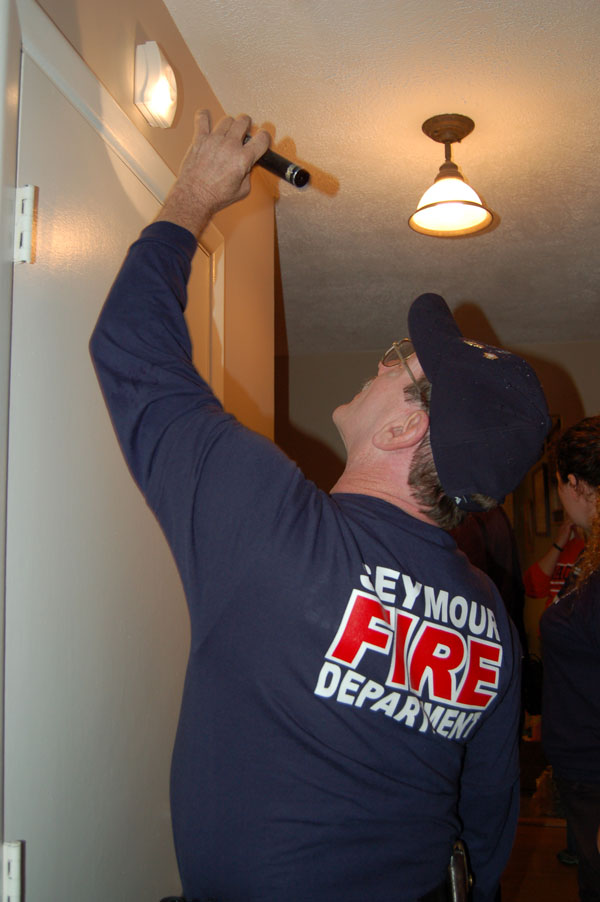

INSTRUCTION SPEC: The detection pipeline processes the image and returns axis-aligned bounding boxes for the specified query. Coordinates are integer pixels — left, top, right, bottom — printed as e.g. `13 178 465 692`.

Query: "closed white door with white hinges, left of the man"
5 44 203 902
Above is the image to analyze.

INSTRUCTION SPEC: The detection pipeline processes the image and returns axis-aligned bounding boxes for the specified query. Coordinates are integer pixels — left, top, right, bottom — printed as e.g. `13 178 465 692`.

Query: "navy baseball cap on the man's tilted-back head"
408 294 551 510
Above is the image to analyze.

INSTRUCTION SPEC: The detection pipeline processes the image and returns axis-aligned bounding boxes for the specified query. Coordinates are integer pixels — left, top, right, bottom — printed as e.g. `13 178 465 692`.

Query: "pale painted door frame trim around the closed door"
0 0 225 852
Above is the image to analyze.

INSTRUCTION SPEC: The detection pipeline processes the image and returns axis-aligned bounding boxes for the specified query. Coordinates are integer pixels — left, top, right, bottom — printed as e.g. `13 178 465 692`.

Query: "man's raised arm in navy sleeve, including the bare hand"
90 110 269 506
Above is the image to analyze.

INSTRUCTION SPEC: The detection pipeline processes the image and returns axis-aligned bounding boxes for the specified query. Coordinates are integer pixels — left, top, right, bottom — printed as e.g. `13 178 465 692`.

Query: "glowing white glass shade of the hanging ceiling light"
408 177 493 238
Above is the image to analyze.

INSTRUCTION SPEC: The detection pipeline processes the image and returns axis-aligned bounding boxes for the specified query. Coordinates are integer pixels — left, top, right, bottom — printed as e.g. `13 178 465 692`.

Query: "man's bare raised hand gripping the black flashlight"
155 110 270 238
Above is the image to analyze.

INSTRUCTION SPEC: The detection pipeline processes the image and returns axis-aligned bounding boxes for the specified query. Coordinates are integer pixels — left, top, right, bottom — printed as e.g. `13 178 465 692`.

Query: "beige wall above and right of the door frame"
38 0 274 436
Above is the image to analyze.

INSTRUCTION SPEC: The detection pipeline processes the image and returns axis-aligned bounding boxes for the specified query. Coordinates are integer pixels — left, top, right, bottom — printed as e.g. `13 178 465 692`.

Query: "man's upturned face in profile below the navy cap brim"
333 354 423 453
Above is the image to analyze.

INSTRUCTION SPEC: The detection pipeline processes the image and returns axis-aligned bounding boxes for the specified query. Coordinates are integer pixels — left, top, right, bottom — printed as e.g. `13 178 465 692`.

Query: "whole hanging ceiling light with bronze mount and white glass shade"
408 113 494 238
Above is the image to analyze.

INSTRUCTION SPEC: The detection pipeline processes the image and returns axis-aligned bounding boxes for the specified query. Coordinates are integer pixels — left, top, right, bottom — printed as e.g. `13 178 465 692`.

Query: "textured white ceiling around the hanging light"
166 0 600 353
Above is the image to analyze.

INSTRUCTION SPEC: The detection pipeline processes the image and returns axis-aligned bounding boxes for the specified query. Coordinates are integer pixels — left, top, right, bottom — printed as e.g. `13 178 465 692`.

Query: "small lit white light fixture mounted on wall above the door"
133 41 177 128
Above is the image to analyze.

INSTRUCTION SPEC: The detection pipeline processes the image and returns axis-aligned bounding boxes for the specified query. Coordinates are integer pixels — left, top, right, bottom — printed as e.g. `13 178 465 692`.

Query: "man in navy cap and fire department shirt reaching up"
86 112 549 902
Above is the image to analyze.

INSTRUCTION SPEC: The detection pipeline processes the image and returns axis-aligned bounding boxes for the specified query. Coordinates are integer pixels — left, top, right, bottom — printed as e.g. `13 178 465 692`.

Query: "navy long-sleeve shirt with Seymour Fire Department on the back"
91 222 520 902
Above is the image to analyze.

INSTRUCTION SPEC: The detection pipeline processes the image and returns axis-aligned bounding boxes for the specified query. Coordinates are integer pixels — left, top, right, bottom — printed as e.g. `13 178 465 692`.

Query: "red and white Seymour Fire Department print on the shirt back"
314 564 502 741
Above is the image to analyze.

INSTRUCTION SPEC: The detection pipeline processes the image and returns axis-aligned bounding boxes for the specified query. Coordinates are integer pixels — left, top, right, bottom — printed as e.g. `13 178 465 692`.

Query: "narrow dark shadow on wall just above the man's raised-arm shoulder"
274 227 344 492
